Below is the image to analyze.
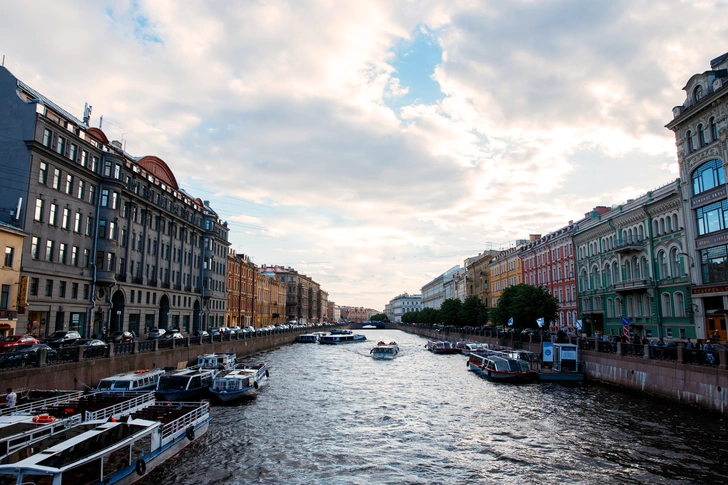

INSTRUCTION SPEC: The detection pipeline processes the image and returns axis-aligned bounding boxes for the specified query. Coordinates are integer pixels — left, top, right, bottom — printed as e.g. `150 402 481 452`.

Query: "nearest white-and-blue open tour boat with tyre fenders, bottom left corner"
0 402 210 485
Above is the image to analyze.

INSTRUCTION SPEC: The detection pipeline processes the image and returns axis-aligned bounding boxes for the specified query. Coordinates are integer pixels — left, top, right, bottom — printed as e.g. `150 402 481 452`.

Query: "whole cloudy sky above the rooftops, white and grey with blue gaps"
0 0 728 309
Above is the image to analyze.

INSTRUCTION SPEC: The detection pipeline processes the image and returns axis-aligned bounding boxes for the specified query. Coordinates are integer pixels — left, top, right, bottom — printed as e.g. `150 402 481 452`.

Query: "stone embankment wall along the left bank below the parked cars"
0 332 296 391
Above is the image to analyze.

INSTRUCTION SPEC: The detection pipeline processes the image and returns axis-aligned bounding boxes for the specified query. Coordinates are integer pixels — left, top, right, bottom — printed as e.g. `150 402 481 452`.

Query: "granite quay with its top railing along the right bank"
396 323 728 414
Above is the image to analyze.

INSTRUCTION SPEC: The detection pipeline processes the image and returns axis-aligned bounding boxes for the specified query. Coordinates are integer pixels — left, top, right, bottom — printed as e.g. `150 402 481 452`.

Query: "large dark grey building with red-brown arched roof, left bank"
0 64 229 336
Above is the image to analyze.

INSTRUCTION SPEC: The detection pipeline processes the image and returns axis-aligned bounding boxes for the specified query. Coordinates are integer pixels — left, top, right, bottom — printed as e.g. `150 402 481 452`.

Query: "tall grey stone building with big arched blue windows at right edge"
666 54 728 340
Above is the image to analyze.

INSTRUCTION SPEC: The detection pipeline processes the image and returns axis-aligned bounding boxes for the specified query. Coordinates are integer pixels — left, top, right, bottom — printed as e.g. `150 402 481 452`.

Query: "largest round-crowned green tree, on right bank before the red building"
491 283 559 328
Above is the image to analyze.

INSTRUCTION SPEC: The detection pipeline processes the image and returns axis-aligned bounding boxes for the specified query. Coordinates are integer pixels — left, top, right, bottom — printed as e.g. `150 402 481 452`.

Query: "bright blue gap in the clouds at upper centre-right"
385 26 444 111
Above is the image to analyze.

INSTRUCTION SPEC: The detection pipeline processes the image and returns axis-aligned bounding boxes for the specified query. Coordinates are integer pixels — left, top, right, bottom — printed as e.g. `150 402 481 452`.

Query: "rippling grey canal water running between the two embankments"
142 330 728 485
